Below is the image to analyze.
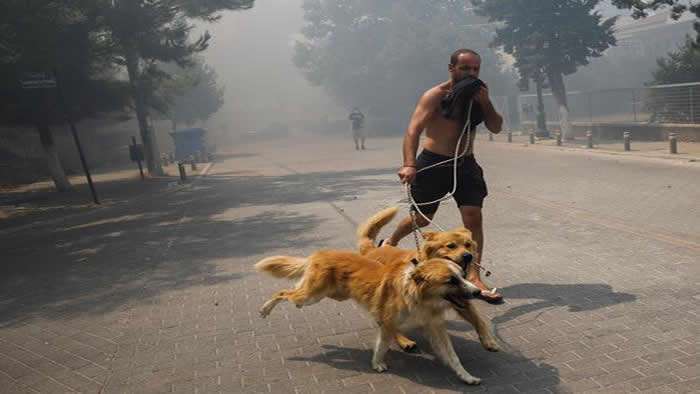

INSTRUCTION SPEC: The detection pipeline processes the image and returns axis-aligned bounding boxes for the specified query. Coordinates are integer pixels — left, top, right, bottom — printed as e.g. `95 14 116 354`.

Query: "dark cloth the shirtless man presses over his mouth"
440 77 486 129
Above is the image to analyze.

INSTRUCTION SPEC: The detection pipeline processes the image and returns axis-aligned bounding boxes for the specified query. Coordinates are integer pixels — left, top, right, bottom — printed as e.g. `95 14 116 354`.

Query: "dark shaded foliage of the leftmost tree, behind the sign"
0 0 128 125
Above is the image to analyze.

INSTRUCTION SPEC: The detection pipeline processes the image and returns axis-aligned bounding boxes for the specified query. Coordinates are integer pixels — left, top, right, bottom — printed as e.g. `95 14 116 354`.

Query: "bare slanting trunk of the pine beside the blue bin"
125 48 163 175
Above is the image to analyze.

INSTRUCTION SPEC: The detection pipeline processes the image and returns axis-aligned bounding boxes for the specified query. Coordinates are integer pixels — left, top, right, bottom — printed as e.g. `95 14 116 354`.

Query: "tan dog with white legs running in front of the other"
255 251 481 384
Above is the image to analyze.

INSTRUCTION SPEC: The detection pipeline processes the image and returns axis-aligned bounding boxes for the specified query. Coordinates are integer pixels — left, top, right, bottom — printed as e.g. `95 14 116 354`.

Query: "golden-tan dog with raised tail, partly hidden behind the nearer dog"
357 207 500 352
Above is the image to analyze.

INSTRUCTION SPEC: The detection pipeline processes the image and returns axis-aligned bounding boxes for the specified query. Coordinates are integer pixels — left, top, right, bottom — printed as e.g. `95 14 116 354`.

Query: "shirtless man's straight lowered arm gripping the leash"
399 91 437 183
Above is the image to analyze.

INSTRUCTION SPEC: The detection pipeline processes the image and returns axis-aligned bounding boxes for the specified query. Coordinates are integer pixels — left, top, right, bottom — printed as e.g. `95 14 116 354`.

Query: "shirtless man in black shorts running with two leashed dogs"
386 49 503 303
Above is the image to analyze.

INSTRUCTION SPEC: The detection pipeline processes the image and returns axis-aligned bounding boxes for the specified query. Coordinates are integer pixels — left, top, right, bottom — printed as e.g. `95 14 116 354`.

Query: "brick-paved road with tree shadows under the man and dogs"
0 134 700 393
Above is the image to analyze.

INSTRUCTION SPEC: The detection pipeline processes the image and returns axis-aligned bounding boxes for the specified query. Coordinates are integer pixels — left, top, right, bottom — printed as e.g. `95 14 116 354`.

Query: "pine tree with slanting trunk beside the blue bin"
96 0 254 175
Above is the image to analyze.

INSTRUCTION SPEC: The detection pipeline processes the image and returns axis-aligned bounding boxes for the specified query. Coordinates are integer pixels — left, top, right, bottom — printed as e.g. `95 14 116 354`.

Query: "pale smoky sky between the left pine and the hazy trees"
197 0 344 132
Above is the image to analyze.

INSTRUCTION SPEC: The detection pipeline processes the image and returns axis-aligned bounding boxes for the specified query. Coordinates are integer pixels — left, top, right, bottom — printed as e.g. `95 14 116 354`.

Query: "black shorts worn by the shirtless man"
411 149 488 214
